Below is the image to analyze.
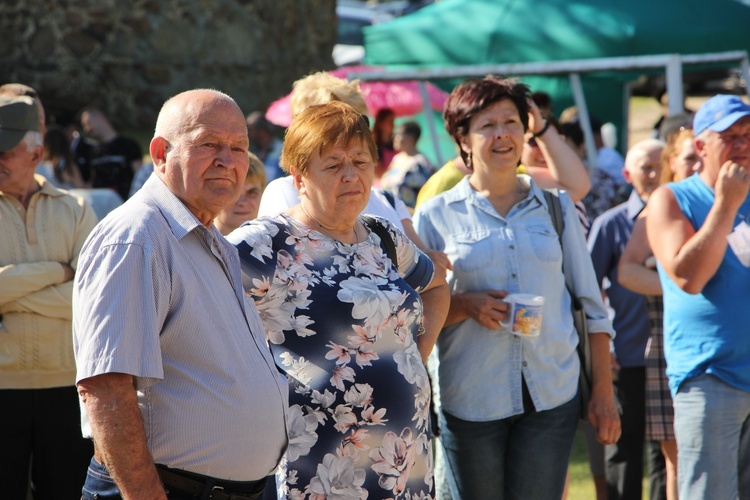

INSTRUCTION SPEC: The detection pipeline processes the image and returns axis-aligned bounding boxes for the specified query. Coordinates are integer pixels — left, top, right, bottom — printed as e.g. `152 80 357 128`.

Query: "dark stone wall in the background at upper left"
0 0 336 129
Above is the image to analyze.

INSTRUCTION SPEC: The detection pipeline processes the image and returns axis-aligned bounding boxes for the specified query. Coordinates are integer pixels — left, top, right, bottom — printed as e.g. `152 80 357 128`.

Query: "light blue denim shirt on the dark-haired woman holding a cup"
414 175 614 421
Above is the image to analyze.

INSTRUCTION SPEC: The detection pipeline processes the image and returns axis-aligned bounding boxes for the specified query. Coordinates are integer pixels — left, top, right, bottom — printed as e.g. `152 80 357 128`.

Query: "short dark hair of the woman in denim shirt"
443 75 531 161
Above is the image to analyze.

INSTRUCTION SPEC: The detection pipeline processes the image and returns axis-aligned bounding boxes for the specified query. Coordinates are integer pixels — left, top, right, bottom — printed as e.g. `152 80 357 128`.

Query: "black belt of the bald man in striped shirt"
156 464 266 500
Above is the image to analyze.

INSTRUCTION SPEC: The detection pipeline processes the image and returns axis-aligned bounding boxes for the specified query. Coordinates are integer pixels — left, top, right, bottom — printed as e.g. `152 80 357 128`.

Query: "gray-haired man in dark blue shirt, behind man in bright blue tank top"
588 139 664 500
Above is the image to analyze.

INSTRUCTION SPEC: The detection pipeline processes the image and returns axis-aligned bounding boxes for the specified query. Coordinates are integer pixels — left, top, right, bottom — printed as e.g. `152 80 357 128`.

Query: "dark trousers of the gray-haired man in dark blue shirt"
606 367 646 500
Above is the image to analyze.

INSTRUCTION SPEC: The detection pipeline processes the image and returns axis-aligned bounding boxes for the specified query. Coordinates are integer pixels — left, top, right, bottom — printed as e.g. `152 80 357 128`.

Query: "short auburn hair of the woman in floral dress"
280 101 378 175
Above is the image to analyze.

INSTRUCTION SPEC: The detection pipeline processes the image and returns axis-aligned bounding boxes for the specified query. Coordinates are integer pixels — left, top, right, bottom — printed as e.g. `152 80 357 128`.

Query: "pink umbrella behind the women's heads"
266 66 448 127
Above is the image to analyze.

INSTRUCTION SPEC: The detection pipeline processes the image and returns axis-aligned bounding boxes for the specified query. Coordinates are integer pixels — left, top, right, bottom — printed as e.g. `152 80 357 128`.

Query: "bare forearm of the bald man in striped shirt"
78 373 166 499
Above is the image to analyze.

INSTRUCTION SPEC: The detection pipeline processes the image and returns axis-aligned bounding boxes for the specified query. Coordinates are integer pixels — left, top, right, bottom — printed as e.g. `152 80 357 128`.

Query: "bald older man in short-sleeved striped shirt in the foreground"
73 90 288 500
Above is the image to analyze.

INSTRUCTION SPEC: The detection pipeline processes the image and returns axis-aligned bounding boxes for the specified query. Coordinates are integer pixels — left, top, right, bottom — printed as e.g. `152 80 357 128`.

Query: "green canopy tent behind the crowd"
365 0 750 160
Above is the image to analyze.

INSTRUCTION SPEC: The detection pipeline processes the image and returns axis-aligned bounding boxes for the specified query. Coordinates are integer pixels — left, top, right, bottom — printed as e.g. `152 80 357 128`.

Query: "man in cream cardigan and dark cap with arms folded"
0 94 97 500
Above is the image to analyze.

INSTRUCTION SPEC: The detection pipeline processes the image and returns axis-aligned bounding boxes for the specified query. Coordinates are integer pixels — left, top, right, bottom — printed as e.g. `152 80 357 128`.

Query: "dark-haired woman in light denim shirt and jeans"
415 76 620 499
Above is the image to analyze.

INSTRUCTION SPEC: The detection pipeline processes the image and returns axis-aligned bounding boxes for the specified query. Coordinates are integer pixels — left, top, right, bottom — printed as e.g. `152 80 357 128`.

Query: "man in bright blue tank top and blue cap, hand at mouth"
646 94 750 500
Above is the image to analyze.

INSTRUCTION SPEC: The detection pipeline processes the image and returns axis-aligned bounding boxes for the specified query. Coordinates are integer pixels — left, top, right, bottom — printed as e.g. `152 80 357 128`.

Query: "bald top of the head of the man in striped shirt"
154 89 245 141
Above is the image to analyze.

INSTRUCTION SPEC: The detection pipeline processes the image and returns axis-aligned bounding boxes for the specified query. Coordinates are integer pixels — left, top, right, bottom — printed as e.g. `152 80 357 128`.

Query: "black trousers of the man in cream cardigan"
0 387 94 500
